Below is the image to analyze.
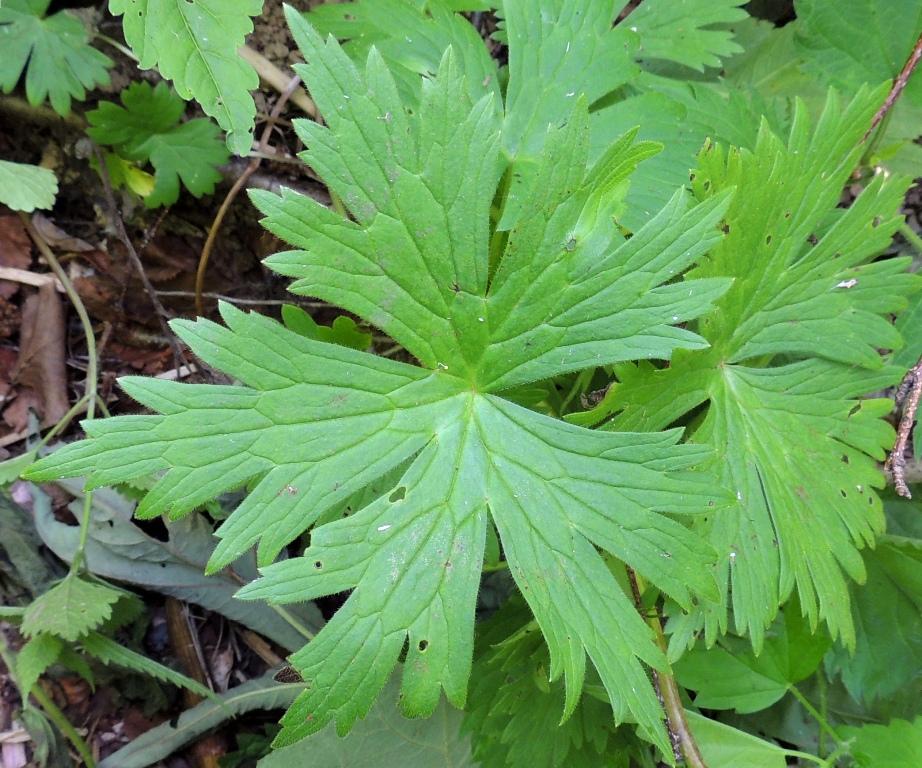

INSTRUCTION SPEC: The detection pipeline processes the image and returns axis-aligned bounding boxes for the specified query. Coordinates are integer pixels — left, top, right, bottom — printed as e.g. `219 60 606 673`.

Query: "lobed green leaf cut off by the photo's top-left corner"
0 0 112 115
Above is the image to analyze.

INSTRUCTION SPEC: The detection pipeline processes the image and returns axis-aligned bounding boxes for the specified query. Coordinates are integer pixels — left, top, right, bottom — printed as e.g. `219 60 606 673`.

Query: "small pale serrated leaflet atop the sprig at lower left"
22 575 122 642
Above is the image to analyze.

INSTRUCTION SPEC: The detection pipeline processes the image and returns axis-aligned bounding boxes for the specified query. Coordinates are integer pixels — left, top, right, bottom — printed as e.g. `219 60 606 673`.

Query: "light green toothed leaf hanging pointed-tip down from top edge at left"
109 0 263 156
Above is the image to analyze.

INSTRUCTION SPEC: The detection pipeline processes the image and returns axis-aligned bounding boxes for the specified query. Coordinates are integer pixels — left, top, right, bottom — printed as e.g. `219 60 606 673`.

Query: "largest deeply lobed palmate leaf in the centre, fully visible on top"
29 6 730 753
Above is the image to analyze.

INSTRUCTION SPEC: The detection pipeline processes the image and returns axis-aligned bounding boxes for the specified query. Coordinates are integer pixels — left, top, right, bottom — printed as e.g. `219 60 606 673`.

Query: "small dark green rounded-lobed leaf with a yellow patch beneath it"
87 82 228 208
